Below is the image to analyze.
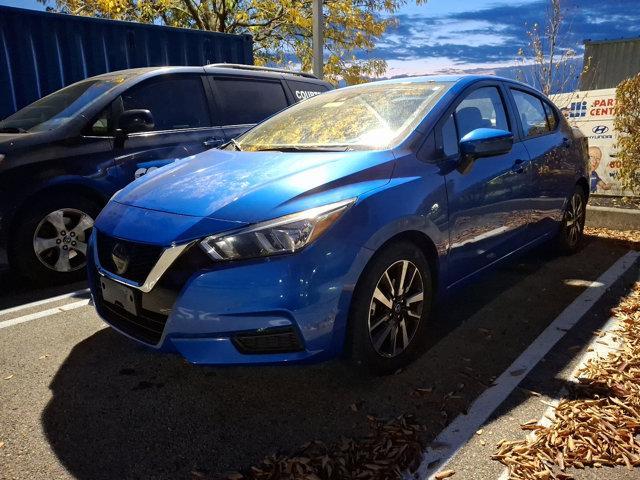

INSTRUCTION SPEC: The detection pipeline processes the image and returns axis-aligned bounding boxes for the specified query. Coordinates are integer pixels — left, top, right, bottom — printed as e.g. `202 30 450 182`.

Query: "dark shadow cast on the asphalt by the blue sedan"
42 240 636 480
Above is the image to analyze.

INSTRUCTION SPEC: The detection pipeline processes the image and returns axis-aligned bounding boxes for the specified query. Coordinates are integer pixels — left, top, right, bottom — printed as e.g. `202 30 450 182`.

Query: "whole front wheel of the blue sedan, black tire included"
349 241 433 375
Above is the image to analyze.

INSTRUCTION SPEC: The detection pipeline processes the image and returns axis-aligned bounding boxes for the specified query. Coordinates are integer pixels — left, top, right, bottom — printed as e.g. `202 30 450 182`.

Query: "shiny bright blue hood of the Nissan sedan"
114 150 394 223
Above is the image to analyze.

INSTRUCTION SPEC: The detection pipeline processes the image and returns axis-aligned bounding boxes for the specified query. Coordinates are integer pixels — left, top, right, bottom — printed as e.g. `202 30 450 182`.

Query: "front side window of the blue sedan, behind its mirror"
456 87 509 138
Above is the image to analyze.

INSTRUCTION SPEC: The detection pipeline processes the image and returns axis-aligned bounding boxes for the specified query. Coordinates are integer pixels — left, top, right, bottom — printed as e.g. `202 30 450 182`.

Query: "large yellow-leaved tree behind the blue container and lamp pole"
38 0 427 84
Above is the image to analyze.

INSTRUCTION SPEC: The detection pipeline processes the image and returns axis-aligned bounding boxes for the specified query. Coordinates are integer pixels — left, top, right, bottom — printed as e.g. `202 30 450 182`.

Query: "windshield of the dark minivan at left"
0 79 118 133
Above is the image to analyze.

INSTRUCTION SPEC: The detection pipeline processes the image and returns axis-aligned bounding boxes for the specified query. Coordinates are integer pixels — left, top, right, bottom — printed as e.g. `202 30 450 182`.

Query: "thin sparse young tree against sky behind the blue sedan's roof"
516 0 589 95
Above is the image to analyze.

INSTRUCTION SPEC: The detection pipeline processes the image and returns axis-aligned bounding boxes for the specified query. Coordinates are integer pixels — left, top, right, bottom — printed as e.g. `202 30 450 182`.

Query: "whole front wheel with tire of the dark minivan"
9 192 100 285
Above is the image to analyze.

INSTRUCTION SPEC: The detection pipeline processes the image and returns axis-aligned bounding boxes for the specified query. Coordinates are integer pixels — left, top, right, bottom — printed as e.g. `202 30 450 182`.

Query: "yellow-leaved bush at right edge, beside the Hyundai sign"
613 74 640 193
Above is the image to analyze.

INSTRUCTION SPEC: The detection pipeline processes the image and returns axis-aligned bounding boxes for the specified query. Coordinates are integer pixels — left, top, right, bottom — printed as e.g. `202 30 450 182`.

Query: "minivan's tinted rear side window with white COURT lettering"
216 78 288 125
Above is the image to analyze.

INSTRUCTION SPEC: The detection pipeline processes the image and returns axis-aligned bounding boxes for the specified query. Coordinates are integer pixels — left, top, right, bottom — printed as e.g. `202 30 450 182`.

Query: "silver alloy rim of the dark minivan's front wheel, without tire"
33 208 93 273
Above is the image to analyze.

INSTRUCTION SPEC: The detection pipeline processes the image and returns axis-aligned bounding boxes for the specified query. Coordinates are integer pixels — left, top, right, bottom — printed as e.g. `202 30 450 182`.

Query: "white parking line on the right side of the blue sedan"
417 252 640 479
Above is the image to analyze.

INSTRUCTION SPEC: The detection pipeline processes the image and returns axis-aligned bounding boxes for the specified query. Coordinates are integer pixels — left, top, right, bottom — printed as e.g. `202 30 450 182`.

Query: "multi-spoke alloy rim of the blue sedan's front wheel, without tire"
368 260 425 357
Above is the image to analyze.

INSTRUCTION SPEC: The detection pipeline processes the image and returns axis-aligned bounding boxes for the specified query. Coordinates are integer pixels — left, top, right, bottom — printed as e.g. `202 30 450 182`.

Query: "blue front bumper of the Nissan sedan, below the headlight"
88 225 372 365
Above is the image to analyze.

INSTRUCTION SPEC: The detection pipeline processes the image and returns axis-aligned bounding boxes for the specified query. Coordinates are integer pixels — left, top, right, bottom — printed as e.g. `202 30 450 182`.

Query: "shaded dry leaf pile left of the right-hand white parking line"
220 416 423 480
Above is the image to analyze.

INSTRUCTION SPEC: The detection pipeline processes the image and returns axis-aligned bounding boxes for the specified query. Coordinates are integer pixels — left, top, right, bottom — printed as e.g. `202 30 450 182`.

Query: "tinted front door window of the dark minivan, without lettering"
122 76 211 130
